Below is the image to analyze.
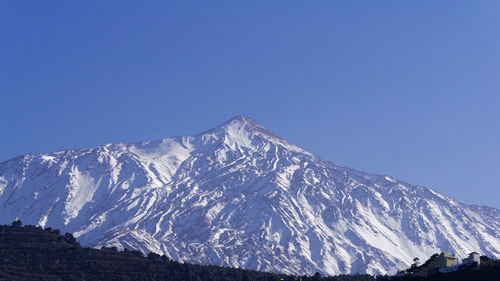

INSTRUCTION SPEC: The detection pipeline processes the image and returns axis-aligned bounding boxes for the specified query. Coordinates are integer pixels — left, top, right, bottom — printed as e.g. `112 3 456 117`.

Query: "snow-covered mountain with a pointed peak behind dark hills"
0 116 500 274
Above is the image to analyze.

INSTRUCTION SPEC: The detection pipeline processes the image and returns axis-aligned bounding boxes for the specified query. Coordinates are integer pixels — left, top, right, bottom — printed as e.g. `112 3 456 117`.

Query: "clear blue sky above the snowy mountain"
0 0 500 208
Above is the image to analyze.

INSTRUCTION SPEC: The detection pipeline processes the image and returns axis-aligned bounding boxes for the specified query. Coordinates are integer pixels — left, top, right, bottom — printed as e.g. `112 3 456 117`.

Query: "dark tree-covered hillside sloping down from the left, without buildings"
0 222 375 281
